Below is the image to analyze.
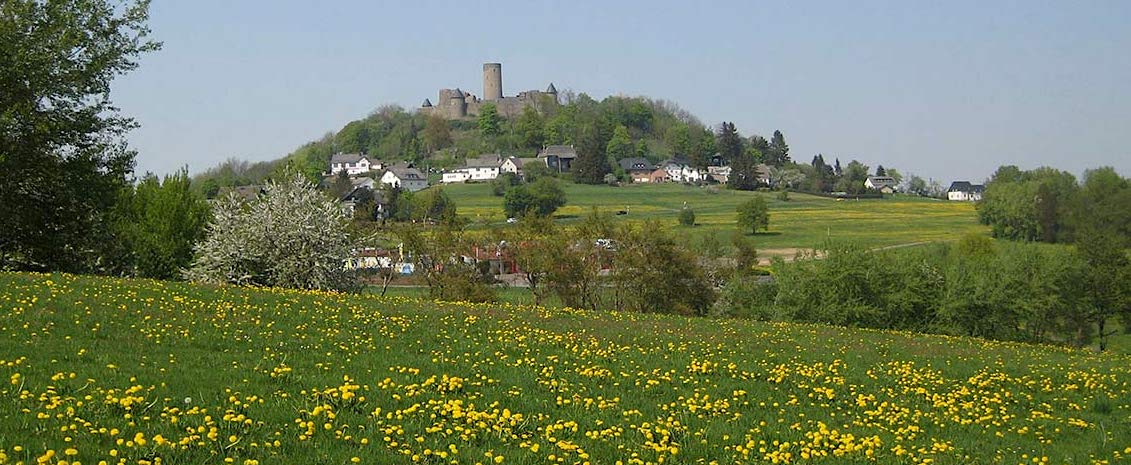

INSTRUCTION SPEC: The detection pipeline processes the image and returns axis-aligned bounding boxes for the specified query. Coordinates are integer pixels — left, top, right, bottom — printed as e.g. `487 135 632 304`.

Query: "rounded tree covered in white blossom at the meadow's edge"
185 174 357 291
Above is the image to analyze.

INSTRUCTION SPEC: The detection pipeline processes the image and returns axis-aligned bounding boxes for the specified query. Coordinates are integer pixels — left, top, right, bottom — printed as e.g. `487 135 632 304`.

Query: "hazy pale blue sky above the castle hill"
114 0 1131 183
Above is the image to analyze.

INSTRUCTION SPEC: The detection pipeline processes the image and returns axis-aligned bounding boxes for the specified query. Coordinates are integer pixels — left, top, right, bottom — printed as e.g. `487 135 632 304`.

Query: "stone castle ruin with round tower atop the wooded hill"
421 63 558 120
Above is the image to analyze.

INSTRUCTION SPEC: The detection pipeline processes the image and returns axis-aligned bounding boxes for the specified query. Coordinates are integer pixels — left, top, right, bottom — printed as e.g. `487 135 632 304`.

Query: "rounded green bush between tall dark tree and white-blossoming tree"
113 170 211 279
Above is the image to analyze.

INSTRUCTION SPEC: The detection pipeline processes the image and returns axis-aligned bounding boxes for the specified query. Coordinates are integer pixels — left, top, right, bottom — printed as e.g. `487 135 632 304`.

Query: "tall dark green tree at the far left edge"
0 0 161 273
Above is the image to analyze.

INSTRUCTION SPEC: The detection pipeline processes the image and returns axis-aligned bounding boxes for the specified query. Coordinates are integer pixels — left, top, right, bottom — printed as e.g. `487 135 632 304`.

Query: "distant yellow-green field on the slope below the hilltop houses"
443 183 988 256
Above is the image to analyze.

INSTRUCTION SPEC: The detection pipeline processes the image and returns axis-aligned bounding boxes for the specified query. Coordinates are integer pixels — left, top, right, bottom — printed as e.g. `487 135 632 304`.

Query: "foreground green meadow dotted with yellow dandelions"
0 274 1131 465
